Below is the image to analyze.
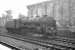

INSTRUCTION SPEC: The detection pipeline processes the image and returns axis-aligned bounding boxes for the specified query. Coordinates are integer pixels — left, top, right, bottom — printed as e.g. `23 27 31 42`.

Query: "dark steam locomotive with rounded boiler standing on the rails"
5 16 57 36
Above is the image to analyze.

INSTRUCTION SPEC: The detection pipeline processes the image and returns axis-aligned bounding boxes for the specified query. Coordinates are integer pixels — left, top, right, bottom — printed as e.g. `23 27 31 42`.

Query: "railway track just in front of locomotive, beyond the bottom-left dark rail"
1 33 75 49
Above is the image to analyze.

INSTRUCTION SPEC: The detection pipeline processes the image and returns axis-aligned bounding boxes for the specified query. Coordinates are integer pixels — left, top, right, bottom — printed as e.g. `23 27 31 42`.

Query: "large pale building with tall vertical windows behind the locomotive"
27 0 75 26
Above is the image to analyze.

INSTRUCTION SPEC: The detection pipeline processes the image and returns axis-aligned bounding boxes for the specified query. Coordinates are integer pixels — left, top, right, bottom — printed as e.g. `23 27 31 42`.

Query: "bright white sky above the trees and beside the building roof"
0 0 47 18
